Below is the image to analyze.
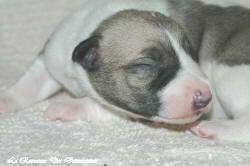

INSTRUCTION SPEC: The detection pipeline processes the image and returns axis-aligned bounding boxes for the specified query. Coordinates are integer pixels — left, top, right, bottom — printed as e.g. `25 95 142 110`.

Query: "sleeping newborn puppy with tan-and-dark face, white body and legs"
0 0 211 128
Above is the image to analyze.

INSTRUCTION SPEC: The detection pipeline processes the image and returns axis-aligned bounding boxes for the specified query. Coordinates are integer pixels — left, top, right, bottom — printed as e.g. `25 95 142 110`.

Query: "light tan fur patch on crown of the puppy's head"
93 10 186 65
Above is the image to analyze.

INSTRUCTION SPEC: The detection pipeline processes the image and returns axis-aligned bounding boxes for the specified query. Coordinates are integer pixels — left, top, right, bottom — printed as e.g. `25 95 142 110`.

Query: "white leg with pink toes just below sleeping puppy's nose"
191 116 250 142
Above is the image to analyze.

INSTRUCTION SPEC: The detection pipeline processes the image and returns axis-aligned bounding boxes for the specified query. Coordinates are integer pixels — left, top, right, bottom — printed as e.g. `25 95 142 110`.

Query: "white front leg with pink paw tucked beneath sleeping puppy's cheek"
45 97 119 122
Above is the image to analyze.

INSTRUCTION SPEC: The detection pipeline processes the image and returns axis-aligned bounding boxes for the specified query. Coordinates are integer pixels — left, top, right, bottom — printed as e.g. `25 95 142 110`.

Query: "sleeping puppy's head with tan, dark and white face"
73 10 211 124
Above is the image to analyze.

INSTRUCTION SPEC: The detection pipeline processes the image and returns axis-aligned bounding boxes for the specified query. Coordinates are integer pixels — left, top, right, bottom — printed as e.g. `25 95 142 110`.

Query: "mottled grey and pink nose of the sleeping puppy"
193 90 212 110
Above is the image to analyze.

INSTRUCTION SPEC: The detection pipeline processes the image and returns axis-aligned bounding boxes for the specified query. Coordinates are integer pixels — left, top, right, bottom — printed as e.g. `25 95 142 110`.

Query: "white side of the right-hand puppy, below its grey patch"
211 65 250 118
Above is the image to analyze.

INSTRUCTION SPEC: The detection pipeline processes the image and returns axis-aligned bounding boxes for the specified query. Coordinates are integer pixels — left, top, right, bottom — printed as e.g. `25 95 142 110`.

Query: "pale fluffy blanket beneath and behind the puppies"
0 0 250 166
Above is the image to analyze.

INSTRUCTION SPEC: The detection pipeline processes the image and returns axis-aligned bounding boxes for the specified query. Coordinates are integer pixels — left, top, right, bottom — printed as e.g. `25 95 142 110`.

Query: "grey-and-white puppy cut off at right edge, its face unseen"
168 0 250 141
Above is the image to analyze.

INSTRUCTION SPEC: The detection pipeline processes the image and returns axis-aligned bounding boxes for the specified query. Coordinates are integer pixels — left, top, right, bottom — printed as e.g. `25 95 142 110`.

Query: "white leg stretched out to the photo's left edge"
0 56 61 113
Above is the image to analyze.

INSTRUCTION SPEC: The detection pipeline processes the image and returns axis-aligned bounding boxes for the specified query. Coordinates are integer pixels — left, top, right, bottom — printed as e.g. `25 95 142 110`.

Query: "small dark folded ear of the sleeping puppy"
72 35 101 71
